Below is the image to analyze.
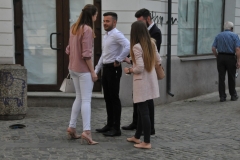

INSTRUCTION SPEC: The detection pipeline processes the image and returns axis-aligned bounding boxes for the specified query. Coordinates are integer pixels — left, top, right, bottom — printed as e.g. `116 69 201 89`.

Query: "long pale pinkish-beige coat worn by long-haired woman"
133 43 161 103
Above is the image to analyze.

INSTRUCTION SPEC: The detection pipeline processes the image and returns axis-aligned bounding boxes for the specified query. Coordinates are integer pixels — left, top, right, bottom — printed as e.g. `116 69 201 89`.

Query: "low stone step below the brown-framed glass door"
27 92 104 99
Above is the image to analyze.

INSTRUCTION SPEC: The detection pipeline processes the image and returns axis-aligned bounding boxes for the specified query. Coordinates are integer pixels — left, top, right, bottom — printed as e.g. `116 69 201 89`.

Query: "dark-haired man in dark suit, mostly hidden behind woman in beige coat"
122 8 162 135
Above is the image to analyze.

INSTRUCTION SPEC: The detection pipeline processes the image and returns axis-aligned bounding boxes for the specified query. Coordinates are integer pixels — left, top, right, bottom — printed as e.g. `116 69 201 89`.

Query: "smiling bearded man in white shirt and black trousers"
95 12 130 136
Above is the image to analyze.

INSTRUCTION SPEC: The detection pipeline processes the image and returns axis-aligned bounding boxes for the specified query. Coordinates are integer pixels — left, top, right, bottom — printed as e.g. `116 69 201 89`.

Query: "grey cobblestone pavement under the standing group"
0 88 240 160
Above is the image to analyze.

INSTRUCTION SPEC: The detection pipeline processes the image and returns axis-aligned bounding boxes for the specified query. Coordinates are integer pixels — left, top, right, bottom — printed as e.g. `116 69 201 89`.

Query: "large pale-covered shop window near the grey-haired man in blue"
178 0 224 56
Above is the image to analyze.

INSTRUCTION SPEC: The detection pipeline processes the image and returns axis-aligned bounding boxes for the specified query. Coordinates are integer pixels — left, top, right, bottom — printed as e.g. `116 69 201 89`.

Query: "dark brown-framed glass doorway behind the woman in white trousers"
14 0 101 92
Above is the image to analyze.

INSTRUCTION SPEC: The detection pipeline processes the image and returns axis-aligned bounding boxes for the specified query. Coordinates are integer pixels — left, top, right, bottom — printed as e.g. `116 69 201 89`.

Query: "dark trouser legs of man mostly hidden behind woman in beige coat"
132 99 154 130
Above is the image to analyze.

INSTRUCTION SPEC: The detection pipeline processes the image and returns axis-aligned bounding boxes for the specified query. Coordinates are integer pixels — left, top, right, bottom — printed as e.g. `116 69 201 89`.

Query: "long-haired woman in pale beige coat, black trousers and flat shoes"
124 21 161 149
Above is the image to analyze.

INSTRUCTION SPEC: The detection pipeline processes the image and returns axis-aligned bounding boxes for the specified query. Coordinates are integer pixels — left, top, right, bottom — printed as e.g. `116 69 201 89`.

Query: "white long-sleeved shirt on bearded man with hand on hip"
95 28 130 73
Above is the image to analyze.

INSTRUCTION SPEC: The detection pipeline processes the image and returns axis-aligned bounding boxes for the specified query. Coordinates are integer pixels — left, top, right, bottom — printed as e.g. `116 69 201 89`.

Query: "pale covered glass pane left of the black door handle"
22 0 57 84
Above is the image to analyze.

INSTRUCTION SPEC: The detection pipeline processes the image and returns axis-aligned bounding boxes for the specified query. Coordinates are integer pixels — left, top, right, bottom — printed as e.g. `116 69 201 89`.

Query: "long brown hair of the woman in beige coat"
130 21 156 72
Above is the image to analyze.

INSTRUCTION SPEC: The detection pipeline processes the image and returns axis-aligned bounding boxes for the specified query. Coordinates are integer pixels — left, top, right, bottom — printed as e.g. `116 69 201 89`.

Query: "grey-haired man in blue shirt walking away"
212 22 240 102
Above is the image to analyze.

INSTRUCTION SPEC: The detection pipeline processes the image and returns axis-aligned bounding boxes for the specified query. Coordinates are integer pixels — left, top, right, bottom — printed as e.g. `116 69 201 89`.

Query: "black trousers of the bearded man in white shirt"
102 65 122 130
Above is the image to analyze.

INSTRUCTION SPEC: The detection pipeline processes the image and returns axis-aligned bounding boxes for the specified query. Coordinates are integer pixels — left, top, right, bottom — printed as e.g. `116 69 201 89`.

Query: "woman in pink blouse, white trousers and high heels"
66 4 98 145
